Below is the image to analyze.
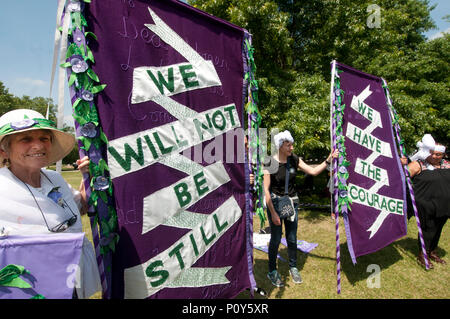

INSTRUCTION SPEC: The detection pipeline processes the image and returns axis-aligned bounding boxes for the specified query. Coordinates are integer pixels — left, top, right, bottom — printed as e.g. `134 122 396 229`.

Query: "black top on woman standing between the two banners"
265 154 299 197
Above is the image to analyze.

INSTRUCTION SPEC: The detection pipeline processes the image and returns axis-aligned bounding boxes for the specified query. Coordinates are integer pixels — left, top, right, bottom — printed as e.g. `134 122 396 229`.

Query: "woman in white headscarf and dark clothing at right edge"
408 134 450 268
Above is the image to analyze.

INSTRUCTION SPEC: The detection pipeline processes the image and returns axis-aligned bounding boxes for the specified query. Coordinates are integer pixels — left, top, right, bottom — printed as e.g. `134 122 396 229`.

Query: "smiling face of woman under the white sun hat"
7 130 52 169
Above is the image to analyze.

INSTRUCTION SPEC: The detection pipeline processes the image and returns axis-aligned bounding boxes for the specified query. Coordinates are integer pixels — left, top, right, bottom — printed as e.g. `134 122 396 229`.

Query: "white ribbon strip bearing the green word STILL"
124 196 242 299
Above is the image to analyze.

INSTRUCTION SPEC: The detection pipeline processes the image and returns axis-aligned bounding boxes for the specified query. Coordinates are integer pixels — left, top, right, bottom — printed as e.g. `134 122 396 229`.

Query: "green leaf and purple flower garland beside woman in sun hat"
61 0 119 255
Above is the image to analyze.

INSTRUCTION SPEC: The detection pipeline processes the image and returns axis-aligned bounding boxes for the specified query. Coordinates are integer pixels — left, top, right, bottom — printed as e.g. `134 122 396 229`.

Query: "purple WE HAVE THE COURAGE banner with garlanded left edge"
333 63 407 262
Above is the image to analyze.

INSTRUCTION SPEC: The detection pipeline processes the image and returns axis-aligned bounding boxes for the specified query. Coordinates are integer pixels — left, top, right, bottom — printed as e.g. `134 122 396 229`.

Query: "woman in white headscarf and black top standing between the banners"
264 131 338 287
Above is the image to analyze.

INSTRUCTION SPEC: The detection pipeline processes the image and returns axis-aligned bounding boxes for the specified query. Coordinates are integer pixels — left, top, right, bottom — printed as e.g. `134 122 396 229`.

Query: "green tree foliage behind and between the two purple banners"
189 0 450 157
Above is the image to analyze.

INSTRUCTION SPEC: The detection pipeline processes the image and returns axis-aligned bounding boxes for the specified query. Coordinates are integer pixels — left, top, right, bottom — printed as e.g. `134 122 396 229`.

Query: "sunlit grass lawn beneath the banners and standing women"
62 171 450 299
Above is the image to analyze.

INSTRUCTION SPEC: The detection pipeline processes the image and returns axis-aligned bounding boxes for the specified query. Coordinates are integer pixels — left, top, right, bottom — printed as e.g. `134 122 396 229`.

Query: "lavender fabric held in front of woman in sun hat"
0 233 84 299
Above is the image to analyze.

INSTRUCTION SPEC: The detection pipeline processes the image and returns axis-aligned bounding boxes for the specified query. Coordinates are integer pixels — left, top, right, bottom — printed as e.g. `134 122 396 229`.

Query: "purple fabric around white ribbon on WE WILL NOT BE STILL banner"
85 0 252 298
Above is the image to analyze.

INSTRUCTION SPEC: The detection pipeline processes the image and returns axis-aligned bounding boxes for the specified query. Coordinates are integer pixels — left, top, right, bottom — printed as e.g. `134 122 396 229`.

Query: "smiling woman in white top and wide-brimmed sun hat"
0 109 101 298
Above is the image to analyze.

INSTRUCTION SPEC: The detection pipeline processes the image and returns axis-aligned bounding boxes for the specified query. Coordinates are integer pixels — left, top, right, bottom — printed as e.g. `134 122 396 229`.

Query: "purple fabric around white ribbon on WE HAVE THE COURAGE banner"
337 63 407 257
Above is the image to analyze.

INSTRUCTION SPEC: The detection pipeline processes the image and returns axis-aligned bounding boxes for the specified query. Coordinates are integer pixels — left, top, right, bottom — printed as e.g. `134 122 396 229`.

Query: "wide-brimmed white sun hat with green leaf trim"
0 109 75 167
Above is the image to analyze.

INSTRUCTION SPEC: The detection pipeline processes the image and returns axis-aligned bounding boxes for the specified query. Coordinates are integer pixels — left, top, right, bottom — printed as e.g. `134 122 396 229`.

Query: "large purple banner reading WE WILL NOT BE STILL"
85 0 252 298
